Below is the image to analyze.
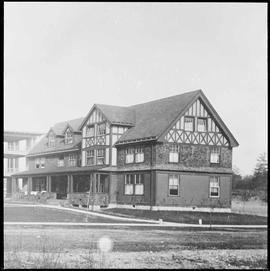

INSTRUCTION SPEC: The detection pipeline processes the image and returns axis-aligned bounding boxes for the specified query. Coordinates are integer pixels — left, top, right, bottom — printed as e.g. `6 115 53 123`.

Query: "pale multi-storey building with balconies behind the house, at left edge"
4 131 41 197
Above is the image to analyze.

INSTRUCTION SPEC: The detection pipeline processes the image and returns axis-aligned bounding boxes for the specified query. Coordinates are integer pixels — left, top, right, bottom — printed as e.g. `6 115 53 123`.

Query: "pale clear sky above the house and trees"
4 2 268 175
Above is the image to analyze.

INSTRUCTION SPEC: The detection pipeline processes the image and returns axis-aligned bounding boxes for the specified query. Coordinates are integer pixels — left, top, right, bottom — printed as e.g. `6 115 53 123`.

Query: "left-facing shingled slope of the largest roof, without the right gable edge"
117 90 200 144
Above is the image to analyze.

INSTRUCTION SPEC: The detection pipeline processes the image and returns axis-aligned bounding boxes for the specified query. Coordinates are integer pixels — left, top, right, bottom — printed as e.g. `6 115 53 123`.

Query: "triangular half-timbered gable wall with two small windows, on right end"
165 99 229 146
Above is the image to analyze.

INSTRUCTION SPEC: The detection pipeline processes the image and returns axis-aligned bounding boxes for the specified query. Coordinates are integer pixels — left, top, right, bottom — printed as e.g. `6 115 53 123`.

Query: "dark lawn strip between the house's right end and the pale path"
99 208 267 225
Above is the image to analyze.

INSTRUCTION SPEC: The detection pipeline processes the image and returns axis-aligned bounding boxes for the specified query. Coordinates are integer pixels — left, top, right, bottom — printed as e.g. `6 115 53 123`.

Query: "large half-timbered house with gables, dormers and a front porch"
13 90 238 212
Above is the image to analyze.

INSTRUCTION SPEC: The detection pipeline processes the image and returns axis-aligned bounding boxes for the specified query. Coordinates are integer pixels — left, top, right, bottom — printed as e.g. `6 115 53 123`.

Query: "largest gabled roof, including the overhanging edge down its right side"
115 90 239 147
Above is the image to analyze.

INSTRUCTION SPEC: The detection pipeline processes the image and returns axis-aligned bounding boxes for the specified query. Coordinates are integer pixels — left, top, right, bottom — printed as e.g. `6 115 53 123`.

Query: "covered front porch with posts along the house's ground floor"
12 173 109 207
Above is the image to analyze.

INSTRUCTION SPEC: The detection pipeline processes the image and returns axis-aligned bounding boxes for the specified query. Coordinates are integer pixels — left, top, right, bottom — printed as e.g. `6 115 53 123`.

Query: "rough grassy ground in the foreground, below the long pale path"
4 226 267 269
